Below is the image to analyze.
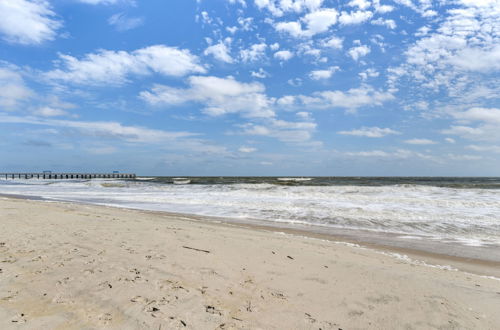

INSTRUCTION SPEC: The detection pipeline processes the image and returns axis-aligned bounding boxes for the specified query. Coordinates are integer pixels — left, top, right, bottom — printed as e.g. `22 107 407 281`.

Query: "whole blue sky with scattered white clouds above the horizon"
0 0 500 176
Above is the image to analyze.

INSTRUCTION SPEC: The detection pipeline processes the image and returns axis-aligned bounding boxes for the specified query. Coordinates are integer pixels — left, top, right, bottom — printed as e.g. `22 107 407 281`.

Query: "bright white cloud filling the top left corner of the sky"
0 0 62 45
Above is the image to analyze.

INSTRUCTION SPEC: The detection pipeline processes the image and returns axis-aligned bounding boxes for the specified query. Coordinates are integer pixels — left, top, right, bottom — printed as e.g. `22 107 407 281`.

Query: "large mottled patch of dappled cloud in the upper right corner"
389 0 500 103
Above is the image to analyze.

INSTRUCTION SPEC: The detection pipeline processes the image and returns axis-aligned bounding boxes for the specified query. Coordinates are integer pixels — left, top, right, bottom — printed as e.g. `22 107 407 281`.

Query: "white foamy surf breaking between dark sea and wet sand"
0 178 500 246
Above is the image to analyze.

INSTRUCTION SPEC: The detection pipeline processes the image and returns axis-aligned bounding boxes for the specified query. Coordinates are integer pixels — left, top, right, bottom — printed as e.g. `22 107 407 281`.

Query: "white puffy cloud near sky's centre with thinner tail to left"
140 76 274 117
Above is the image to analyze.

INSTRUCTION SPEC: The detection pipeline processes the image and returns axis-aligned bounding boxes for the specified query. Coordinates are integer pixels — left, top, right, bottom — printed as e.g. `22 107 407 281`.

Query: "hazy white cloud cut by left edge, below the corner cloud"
0 67 33 110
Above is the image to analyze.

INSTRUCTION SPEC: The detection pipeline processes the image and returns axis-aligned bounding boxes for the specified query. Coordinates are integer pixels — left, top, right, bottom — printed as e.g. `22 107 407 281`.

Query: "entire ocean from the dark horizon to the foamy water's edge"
0 177 500 261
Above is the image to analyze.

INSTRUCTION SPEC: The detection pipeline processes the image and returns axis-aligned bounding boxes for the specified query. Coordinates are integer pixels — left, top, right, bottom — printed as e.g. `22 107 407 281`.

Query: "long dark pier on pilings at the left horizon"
0 171 136 180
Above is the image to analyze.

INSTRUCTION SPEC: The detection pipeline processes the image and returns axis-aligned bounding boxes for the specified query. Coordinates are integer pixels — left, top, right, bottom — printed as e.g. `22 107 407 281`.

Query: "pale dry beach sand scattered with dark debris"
0 198 500 329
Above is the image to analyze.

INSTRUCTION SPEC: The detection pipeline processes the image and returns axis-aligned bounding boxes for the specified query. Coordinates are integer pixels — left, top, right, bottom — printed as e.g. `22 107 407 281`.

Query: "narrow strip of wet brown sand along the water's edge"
0 194 500 280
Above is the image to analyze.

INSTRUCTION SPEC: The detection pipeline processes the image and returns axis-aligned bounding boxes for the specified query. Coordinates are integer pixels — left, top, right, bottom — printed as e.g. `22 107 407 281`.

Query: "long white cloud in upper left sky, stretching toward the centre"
45 45 206 85
